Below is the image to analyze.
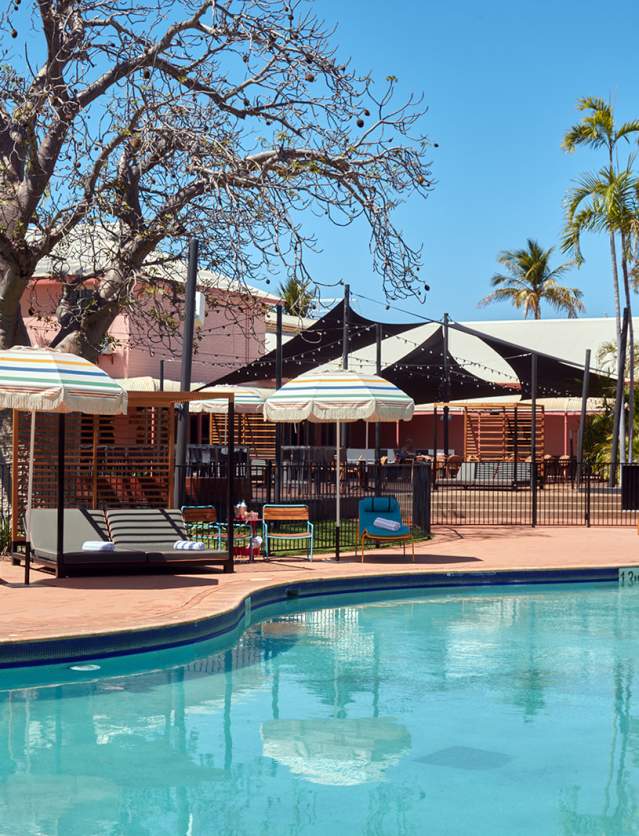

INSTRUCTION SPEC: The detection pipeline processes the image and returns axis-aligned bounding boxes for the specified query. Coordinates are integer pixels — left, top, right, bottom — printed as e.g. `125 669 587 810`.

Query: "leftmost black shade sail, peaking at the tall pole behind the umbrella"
212 301 422 385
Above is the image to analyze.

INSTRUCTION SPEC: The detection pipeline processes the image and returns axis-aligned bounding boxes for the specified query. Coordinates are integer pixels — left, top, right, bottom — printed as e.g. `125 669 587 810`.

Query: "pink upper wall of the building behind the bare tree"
22 279 277 383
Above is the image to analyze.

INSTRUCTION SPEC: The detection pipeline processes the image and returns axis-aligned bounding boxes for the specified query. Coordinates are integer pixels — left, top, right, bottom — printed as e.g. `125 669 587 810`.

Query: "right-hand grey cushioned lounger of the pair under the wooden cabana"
106 508 233 572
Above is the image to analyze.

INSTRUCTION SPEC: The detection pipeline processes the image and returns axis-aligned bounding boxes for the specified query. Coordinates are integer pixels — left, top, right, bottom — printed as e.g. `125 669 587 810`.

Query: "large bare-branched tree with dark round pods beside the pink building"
0 0 431 356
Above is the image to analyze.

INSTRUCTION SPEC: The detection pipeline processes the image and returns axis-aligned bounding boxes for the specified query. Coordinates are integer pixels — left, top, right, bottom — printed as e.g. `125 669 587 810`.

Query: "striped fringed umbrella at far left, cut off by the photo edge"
0 346 128 583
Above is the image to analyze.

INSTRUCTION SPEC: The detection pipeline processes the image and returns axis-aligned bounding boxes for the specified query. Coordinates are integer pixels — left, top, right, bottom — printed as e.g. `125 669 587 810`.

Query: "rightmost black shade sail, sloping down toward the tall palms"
451 323 615 399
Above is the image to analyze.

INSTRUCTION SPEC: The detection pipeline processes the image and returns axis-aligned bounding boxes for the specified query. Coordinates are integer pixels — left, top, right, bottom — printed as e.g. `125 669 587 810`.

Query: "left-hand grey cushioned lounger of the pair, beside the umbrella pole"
26 508 147 578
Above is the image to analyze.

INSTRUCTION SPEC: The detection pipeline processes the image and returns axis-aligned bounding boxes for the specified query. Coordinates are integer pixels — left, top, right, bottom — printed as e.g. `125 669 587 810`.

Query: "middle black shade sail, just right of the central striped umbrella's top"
382 327 520 404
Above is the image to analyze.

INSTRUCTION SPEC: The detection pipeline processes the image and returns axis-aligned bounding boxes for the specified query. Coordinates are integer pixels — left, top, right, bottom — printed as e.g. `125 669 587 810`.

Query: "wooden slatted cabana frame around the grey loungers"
11 391 236 549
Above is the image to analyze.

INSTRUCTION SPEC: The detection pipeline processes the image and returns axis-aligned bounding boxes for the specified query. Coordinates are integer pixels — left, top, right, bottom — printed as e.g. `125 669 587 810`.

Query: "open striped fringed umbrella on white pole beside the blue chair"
264 369 415 560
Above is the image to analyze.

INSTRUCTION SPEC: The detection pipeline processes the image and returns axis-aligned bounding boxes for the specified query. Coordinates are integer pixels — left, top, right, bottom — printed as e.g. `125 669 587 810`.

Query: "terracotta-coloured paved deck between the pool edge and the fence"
0 527 639 641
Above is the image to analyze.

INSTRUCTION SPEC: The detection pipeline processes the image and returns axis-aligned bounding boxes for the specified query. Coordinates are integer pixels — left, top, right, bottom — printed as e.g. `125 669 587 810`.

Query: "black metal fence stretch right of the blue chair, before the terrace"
430 460 639 526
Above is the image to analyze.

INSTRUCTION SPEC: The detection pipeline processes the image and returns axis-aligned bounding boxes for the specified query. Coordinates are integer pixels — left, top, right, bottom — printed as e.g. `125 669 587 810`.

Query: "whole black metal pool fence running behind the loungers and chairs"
8 460 639 553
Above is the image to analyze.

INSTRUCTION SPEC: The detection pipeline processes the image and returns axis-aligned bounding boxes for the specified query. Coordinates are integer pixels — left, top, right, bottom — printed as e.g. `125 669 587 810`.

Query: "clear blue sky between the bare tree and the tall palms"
284 0 639 319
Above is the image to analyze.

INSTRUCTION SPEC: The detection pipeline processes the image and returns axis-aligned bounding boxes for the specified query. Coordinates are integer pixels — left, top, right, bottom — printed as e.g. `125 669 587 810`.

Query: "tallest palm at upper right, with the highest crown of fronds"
561 96 639 334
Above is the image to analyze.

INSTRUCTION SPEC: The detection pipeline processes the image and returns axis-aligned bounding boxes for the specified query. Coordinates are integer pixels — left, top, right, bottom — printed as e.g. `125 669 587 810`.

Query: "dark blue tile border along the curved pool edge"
0 566 619 668
